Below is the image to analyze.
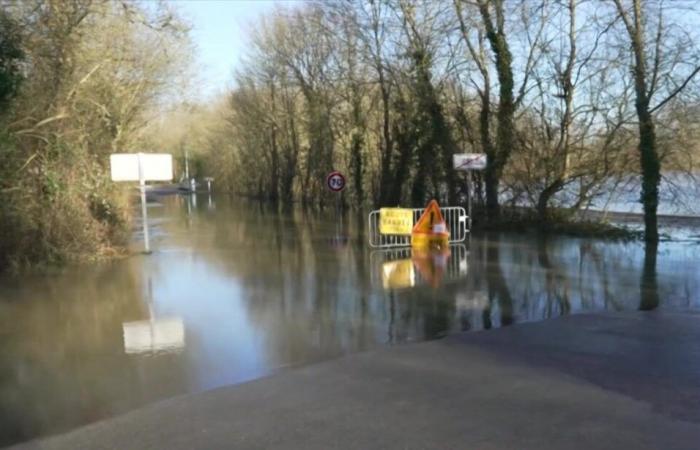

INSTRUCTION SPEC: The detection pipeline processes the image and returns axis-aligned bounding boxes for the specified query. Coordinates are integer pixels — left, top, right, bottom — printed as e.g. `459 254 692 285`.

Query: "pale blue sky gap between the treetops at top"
174 0 302 100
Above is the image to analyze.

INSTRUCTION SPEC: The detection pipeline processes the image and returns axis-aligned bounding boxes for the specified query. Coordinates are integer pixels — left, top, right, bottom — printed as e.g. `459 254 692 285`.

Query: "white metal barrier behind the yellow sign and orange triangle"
367 206 469 248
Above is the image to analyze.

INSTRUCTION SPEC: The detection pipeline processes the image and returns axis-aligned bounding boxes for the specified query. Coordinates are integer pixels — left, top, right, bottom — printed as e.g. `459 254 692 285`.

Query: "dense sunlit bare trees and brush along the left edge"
0 0 189 266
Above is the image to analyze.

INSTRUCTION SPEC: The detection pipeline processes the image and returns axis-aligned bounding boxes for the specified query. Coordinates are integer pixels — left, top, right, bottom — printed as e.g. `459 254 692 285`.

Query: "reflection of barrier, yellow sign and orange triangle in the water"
370 245 468 289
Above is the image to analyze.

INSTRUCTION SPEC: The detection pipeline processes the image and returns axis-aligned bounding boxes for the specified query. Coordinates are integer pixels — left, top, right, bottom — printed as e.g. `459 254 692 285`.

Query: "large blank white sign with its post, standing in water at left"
109 153 173 253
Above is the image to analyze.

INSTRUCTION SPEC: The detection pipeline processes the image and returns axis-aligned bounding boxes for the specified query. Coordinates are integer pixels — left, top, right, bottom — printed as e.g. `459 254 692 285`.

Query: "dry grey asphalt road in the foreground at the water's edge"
10 312 700 450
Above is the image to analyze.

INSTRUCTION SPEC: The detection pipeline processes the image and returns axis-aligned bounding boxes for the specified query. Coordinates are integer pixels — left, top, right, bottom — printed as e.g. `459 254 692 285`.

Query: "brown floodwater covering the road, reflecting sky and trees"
0 196 700 446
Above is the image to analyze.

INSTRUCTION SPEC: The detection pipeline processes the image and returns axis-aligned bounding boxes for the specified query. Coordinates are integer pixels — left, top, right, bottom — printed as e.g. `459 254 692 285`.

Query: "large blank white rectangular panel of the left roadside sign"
109 153 173 181
